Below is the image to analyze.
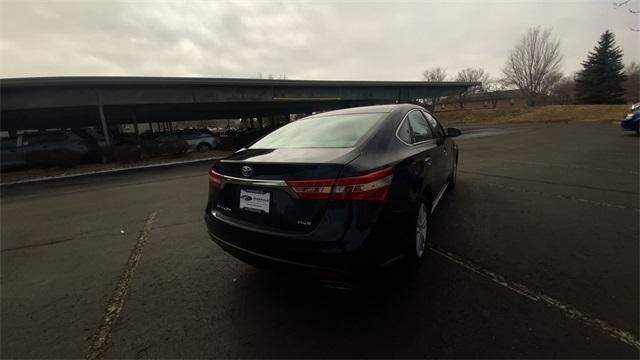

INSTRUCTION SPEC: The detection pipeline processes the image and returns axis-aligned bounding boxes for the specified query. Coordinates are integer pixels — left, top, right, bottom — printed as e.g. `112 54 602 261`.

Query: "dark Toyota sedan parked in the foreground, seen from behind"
205 104 461 273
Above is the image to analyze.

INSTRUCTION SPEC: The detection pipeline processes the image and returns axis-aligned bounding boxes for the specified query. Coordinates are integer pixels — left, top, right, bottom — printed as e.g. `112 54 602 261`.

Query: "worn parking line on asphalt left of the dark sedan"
85 212 158 359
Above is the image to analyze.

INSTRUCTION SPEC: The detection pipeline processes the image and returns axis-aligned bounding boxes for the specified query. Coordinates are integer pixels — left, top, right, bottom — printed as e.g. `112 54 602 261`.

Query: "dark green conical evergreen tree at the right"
576 30 627 104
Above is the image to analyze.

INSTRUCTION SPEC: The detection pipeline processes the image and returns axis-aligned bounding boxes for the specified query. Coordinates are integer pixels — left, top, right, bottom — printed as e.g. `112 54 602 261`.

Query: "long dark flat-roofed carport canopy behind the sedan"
0 77 478 143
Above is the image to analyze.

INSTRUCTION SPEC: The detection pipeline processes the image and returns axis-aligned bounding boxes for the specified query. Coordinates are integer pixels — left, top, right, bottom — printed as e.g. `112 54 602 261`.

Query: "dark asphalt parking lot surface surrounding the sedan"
1 123 640 358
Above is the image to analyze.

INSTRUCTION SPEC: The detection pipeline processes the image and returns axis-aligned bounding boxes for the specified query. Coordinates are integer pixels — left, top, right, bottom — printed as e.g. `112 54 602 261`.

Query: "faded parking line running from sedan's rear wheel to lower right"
428 243 640 349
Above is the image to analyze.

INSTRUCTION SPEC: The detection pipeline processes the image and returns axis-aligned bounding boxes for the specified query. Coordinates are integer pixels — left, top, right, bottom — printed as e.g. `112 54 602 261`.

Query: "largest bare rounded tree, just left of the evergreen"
502 26 562 106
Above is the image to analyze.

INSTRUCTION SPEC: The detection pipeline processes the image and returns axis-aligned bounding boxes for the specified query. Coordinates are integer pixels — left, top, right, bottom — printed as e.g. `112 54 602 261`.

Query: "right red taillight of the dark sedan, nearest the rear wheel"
287 168 393 201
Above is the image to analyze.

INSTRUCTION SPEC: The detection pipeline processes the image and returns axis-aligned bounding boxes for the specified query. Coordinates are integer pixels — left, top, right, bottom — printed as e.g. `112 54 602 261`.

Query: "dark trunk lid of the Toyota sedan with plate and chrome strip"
210 148 359 232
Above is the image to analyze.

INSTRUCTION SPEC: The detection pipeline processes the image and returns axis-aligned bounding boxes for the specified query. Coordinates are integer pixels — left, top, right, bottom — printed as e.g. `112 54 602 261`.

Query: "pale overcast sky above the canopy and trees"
0 0 640 80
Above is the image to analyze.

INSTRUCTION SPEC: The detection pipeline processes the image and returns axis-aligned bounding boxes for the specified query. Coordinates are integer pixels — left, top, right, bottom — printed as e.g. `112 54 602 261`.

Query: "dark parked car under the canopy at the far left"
0 130 99 170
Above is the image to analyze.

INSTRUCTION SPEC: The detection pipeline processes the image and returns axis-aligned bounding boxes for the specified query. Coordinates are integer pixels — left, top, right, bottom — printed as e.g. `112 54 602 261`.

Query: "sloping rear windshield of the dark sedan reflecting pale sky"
251 113 386 149
